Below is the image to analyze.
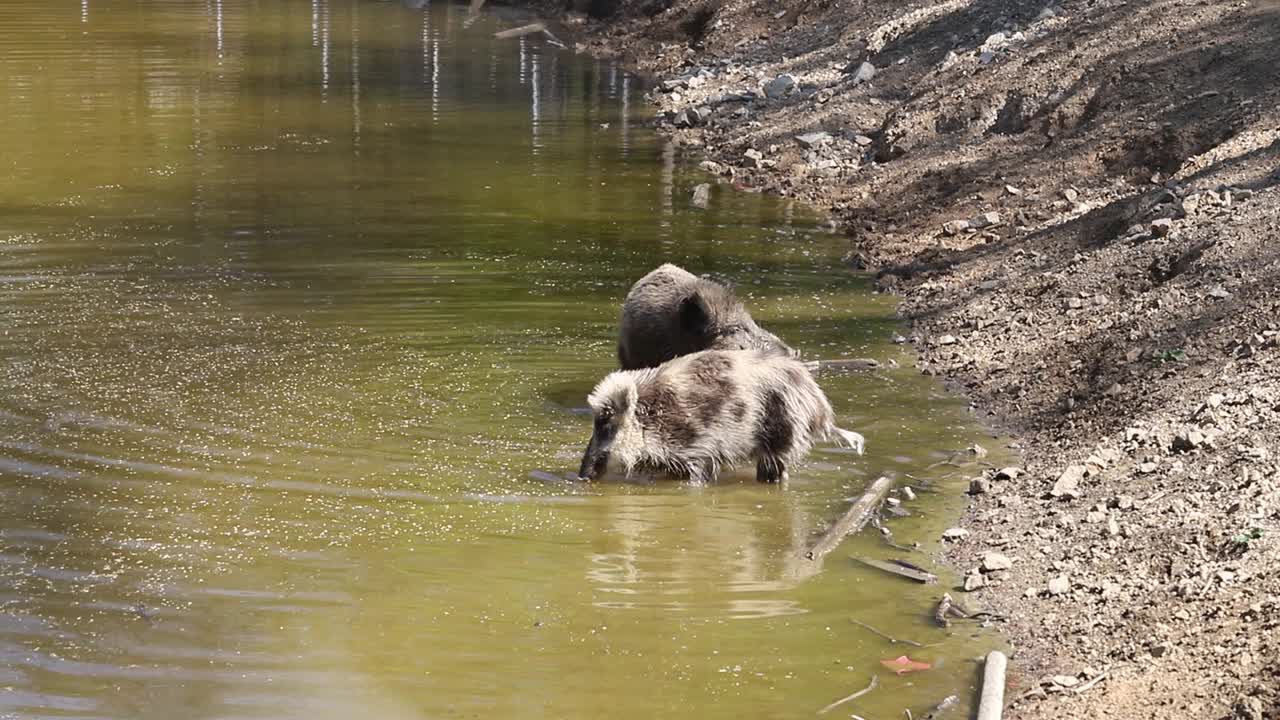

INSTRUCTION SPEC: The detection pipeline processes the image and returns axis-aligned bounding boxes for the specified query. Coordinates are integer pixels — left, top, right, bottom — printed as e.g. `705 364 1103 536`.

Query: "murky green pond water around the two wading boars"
0 0 995 720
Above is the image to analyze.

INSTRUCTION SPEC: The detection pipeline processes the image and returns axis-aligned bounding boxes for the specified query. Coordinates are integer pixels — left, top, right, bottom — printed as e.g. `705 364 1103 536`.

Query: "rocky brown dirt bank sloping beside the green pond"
535 0 1280 720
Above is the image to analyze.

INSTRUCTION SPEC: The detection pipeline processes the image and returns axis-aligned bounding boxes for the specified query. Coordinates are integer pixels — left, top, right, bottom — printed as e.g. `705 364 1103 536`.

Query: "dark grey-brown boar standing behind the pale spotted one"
618 263 796 370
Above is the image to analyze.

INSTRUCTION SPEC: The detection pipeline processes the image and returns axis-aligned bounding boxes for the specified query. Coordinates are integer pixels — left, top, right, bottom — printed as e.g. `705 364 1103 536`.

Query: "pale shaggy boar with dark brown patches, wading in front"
580 350 863 482
